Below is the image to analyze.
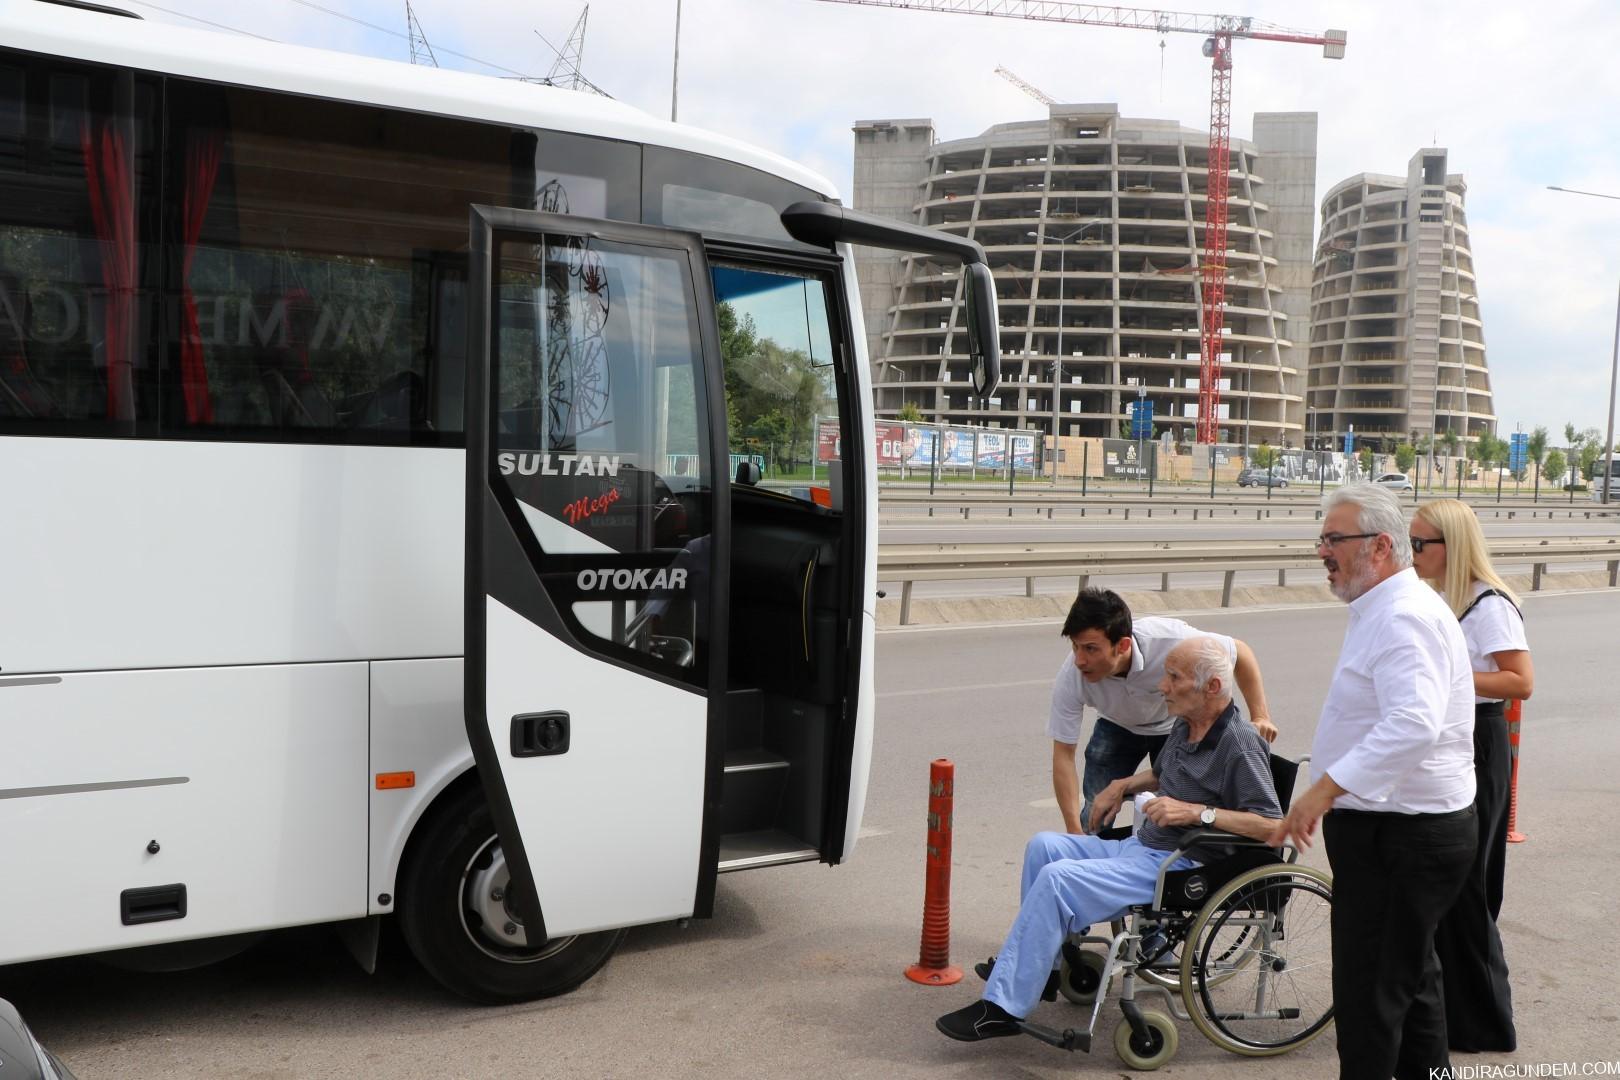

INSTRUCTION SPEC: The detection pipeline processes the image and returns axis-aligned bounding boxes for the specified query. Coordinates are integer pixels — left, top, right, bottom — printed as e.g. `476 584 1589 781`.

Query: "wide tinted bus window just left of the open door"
164 81 512 445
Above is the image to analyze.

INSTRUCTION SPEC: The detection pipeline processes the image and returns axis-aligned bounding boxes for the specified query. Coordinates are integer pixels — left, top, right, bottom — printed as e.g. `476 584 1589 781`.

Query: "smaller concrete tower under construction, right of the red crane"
1306 147 1495 450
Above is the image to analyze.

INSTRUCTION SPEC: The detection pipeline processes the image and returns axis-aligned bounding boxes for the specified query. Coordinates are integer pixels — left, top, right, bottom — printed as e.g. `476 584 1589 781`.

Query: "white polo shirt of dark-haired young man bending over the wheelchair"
1047 615 1238 743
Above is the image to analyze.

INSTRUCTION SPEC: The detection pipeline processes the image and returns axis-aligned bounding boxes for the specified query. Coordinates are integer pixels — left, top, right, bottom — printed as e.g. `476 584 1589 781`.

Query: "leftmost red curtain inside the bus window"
79 121 136 421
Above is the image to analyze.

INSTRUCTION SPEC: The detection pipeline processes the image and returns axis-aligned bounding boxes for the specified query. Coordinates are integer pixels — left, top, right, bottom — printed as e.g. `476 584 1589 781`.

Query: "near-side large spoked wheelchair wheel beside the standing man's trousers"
1181 865 1333 1057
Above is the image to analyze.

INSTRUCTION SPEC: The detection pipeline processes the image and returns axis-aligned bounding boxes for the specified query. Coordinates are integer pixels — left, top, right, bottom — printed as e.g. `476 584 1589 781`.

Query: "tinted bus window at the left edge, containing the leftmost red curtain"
0 60 159 436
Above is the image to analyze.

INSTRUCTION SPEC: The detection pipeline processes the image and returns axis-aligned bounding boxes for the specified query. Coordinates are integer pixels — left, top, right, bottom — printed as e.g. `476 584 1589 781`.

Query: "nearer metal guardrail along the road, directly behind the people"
878 538 1620 625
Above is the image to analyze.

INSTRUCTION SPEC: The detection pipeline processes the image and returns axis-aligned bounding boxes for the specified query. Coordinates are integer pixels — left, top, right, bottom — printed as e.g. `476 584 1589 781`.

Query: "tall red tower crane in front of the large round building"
821 0 1345 442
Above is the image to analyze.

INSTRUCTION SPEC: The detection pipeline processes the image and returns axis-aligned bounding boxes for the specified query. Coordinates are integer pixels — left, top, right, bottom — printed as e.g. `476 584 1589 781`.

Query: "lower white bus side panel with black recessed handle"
0 664 366 963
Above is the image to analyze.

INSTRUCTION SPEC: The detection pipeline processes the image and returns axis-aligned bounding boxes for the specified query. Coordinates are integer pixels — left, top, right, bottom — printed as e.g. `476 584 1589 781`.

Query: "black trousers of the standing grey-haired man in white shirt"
1322 806 1479 1080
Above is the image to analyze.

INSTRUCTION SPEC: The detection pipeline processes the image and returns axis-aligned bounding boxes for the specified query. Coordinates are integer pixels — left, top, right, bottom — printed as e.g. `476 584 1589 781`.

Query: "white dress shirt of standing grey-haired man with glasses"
1311 568 1474 814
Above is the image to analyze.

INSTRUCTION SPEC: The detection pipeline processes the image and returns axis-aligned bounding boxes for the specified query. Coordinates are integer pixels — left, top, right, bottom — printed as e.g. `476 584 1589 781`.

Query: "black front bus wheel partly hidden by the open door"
399 785 624 1006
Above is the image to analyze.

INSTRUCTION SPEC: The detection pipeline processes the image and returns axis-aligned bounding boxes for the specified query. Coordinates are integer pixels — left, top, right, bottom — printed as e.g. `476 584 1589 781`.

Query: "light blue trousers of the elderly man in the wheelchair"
985 832 1197 1017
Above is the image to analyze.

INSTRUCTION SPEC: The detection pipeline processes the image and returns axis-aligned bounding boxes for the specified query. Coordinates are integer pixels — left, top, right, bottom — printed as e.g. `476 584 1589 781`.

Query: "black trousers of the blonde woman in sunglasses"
1434 701 1518 1052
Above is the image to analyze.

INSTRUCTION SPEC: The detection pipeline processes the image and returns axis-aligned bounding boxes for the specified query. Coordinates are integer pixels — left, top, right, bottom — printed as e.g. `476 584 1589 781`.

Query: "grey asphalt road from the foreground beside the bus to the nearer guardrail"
0 591 1620 1080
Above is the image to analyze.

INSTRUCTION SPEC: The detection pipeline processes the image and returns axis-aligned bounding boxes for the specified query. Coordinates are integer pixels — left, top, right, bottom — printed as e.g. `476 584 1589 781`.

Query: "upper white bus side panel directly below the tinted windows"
0 437 463 675
